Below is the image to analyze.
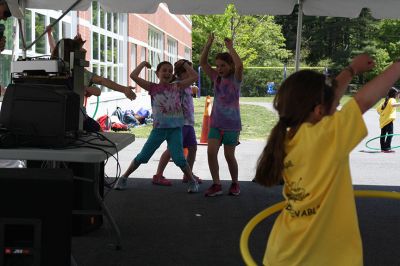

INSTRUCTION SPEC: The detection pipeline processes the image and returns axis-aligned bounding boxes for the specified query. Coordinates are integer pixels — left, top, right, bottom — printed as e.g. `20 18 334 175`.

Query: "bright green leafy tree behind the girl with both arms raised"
192 5 291 96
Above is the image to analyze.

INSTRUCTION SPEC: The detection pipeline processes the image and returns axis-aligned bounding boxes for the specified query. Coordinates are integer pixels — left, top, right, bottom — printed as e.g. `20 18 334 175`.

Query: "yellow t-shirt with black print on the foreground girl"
263 99 367 266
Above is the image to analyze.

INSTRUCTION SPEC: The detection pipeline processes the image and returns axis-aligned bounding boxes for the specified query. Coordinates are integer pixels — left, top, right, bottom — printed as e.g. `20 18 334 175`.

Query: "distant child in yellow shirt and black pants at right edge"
376 87 400 153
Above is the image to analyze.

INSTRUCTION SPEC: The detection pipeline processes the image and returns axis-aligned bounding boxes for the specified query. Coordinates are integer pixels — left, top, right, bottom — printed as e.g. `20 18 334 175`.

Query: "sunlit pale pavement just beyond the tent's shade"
106 103 400 187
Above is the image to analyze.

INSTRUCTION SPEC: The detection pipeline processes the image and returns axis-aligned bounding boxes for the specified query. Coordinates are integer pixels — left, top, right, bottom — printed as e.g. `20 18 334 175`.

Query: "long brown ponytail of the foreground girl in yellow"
255 118 287 187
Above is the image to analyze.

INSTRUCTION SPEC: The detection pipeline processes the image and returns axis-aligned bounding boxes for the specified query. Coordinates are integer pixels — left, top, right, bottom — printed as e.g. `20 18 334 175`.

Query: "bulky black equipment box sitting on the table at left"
0 83 80 147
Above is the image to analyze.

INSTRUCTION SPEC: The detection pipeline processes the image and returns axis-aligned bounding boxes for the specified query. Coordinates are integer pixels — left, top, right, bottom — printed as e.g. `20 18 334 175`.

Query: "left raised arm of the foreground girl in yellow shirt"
332 54 375 109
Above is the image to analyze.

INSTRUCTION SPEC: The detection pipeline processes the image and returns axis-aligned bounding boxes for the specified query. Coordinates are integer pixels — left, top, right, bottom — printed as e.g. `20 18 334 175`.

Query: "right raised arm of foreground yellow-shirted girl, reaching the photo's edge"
354 61 400 113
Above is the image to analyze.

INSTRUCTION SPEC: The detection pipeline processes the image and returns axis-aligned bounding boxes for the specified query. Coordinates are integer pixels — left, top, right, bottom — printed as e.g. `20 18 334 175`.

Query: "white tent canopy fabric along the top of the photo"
14 0 400 18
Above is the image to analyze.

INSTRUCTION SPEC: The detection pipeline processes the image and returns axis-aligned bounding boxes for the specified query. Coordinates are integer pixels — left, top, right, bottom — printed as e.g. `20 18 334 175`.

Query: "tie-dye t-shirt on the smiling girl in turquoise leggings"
148 83 183 128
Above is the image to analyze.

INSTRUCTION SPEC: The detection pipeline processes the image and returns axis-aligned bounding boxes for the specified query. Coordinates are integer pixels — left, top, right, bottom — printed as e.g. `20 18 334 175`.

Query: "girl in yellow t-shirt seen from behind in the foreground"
255 54 400 266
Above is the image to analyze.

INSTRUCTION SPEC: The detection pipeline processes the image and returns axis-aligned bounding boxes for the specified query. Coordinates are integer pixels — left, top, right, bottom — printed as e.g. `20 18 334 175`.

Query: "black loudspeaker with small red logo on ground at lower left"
0 168 73 266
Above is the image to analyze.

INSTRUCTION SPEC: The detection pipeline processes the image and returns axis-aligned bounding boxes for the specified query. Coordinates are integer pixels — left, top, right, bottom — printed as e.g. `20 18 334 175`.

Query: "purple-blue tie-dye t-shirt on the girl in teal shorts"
210 74 242 131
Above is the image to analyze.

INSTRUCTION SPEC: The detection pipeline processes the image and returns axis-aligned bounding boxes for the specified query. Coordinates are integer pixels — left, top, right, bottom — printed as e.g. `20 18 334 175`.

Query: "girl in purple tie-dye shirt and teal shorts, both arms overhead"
200 34 243 197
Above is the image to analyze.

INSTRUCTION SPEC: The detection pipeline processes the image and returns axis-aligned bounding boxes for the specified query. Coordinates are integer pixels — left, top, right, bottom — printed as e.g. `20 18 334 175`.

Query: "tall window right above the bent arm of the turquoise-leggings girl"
148 28 164 83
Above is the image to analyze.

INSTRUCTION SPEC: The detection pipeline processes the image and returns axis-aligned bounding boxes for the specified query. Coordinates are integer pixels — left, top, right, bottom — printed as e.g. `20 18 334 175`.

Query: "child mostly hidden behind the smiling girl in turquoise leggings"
153 59 202 186
